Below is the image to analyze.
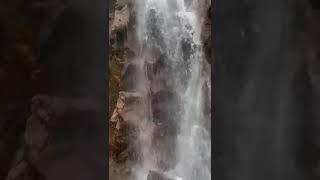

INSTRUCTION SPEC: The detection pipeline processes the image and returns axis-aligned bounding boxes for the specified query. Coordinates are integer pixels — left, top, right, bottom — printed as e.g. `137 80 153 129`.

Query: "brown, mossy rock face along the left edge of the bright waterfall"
109 0 136 172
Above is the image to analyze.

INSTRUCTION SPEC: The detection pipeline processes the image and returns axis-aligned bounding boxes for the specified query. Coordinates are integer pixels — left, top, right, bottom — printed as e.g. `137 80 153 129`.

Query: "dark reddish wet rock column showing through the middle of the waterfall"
146 55 181 171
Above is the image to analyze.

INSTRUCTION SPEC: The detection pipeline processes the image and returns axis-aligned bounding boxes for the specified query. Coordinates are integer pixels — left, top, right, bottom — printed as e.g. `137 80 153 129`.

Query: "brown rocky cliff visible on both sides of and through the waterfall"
109 0 212 179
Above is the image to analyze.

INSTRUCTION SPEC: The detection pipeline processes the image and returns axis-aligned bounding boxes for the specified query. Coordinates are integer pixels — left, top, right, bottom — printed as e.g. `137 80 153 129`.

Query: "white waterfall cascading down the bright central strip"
131 0 211 180
